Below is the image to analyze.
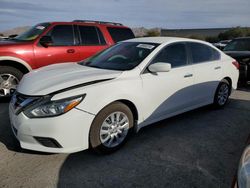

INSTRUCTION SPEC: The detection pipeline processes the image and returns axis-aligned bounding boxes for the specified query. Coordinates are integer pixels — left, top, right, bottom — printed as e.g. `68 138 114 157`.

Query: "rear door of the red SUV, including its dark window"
75 25 109 60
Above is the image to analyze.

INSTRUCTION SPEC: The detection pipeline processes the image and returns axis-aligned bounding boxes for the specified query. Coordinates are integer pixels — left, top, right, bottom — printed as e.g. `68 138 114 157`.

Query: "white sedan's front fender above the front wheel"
52 77 146 123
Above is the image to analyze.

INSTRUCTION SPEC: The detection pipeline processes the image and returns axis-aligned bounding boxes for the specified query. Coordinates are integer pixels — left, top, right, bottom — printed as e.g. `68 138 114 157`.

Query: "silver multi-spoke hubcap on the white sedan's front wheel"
100 112 129 148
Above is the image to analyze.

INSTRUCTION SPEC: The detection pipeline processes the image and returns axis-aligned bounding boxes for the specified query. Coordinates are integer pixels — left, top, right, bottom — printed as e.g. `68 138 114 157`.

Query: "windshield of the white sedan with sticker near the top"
79 42 159 71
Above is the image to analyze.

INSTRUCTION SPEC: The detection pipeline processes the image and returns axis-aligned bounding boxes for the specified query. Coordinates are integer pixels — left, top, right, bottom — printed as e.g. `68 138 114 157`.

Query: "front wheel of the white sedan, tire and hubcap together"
89 102 134 154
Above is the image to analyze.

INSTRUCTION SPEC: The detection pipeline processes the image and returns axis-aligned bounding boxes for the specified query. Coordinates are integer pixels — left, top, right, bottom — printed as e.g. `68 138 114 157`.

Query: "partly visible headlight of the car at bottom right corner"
237 146 250 188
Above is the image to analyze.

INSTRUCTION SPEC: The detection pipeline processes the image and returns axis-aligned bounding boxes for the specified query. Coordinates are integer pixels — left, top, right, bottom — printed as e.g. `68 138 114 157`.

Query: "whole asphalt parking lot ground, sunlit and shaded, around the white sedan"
0 88 250 188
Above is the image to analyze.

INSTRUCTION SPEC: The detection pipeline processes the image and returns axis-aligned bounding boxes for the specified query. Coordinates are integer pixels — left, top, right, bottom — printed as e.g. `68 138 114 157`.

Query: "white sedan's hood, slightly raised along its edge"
17 63 121 96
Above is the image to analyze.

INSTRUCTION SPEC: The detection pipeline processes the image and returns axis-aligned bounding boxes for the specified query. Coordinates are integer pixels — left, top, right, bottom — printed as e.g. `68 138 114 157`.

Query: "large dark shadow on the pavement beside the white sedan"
58 99 250 187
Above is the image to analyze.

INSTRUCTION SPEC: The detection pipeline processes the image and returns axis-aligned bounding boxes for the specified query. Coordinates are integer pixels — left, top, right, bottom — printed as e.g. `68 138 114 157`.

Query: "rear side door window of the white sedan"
188 43 220 63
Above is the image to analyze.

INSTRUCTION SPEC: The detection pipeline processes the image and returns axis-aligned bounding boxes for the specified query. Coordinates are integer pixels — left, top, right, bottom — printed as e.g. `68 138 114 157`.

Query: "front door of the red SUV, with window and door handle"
34 24 81 67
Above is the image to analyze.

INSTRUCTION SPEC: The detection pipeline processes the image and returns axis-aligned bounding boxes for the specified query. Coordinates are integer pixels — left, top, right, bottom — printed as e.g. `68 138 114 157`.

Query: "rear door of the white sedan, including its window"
187 42 222 104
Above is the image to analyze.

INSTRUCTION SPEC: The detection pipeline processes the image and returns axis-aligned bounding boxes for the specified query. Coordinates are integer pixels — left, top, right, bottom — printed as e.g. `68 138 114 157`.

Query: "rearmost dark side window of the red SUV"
107 27 135 43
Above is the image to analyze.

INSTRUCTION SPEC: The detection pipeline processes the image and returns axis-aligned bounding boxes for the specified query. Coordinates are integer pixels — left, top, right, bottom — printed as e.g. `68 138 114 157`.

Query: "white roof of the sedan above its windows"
125 37 208 44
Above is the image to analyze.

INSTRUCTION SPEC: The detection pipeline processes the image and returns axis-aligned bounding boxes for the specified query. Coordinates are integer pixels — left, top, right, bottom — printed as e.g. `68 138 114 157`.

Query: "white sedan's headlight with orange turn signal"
24 95 86 118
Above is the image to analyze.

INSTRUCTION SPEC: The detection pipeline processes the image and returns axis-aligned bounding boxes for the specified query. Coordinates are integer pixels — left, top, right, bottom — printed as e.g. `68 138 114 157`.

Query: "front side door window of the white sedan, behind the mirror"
153 43 187 67
